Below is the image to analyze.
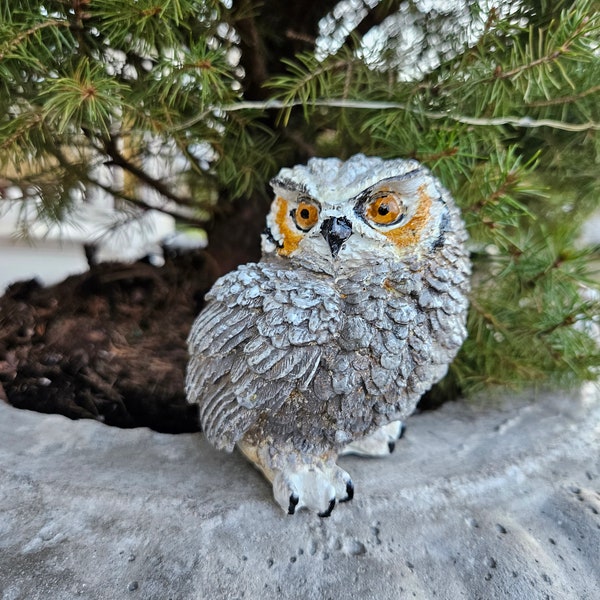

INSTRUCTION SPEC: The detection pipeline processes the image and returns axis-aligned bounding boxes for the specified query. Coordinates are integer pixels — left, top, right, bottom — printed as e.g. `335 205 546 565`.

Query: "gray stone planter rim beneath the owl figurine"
0 386 600 600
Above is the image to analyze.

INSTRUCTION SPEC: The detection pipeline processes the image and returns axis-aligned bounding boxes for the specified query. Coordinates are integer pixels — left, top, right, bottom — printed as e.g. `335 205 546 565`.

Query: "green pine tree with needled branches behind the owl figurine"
0 0 600 400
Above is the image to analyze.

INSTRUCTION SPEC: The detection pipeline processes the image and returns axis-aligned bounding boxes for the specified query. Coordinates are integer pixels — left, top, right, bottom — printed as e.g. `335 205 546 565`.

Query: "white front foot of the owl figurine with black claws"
273 463 354 517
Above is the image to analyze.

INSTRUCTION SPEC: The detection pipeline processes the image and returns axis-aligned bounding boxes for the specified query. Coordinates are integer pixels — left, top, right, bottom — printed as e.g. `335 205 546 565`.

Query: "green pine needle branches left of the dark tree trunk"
0 0 239 223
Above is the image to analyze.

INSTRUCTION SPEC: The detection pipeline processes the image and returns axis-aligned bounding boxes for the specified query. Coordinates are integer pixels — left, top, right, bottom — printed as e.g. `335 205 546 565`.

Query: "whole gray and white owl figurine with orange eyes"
186 154 470 517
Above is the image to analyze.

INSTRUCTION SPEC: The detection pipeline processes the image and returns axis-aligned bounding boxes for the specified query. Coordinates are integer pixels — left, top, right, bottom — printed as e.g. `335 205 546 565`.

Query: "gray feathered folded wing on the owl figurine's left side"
186 264 336 450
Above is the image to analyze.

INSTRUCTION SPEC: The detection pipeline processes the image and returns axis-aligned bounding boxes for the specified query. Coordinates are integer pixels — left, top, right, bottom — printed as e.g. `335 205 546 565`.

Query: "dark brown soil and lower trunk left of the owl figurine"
0 197 266 433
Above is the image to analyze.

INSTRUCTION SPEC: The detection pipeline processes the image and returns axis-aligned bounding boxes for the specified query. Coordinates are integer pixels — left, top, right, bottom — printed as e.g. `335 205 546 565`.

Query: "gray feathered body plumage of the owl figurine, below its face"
186 159 469 451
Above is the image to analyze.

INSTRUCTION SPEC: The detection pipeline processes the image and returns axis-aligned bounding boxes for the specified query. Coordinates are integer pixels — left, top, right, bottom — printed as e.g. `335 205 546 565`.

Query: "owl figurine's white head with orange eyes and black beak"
262 154 452 273
